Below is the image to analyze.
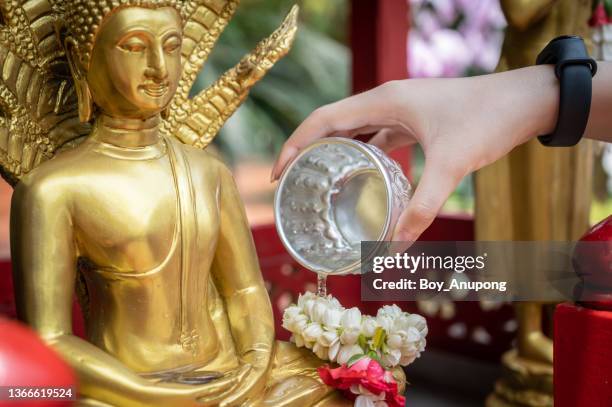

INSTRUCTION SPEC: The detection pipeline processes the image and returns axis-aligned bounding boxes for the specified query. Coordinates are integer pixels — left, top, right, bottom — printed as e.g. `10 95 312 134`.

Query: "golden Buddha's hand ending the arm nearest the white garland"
219 350 271 407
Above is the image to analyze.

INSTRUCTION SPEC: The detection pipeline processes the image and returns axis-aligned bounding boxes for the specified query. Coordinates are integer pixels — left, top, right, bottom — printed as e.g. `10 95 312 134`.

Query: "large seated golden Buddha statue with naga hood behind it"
0 0 348 406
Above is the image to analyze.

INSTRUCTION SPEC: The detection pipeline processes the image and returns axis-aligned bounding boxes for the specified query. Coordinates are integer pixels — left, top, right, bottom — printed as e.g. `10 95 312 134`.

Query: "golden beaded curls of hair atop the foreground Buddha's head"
64 0 185 68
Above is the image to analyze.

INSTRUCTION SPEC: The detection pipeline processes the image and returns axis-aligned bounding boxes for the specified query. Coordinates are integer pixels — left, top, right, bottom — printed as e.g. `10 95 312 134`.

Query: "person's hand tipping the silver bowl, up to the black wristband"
272 66 559 242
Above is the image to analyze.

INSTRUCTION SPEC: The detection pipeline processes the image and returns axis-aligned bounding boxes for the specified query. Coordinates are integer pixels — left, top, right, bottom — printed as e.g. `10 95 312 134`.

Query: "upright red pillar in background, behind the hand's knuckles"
350 0 410 173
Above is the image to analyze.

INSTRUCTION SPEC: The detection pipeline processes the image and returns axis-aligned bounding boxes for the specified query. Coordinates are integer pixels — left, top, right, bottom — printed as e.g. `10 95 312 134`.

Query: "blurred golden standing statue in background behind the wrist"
476 0 593 406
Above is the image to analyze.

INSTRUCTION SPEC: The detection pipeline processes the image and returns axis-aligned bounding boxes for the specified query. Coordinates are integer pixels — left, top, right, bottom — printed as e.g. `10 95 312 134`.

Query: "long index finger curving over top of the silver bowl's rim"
272 86 392 180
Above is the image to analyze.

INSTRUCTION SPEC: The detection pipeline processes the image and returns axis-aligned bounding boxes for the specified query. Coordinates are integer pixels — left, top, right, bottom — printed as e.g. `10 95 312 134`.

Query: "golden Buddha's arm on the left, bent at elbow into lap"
11 180 238 405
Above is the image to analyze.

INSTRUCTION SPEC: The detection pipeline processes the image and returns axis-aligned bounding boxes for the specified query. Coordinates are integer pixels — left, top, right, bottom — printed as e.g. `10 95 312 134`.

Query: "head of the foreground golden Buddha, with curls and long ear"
65 0 182 121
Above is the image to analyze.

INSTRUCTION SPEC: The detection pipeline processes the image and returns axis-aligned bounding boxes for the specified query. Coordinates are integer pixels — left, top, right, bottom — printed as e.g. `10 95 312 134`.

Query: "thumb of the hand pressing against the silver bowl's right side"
393 158 465 242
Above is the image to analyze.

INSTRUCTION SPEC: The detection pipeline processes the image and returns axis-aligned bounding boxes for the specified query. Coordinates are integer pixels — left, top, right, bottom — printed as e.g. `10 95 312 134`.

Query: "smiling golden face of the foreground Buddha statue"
87 7 182 119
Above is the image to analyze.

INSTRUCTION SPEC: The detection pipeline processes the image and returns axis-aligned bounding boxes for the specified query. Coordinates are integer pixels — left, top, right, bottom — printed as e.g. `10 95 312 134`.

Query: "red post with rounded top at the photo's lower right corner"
554 216 612 407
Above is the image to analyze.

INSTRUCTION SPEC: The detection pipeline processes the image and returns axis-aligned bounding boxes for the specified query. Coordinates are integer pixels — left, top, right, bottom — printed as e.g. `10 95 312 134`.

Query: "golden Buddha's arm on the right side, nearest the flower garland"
213 165 274 403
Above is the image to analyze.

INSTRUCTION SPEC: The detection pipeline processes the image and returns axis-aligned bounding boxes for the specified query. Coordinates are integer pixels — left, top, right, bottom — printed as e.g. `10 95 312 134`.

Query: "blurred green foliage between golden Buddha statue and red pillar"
193 0 350 163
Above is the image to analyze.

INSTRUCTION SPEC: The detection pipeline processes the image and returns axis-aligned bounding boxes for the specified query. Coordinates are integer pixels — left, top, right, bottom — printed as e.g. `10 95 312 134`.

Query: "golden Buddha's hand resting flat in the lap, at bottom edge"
141 363 252 407
